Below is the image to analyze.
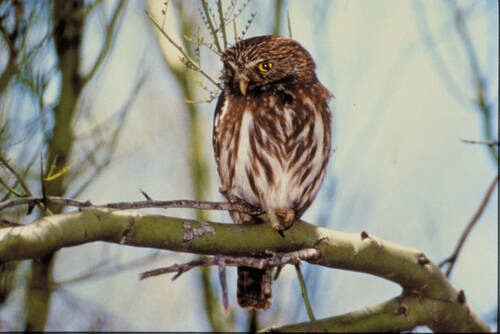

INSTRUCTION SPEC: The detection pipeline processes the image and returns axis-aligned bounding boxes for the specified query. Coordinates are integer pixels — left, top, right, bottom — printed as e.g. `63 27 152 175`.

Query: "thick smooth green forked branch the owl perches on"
0 208 490 332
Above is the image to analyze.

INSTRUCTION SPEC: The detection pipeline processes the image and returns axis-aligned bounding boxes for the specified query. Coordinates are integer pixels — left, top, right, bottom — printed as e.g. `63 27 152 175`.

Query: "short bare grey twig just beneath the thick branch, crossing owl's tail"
139 248 320 281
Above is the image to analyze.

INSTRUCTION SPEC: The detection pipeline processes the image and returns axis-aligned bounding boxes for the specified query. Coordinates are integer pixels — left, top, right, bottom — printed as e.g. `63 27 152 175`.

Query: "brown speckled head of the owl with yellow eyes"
221 35 316 95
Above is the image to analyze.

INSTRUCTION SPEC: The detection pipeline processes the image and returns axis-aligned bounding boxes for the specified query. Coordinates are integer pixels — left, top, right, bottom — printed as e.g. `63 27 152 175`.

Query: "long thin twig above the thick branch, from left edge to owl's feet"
0 196 264 216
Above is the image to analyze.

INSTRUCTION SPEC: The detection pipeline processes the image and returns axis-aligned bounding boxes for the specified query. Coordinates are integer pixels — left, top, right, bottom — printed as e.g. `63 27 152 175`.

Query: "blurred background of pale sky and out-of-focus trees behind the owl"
0 0 499 331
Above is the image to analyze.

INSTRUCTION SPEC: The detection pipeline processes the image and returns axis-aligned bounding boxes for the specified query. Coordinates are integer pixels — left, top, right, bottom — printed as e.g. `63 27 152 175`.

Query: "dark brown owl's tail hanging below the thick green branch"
236 267 272 310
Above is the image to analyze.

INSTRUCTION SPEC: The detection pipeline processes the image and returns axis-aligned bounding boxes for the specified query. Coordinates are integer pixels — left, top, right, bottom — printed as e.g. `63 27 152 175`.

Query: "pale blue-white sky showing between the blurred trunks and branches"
2 0 498 331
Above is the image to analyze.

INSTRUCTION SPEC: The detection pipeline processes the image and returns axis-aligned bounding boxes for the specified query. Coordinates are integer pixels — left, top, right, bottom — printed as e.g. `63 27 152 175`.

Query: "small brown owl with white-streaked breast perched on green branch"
213 35 332 310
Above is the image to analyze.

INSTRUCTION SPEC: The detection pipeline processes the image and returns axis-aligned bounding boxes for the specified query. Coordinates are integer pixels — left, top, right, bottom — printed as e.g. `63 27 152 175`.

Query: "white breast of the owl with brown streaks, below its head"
214 87 329 211
